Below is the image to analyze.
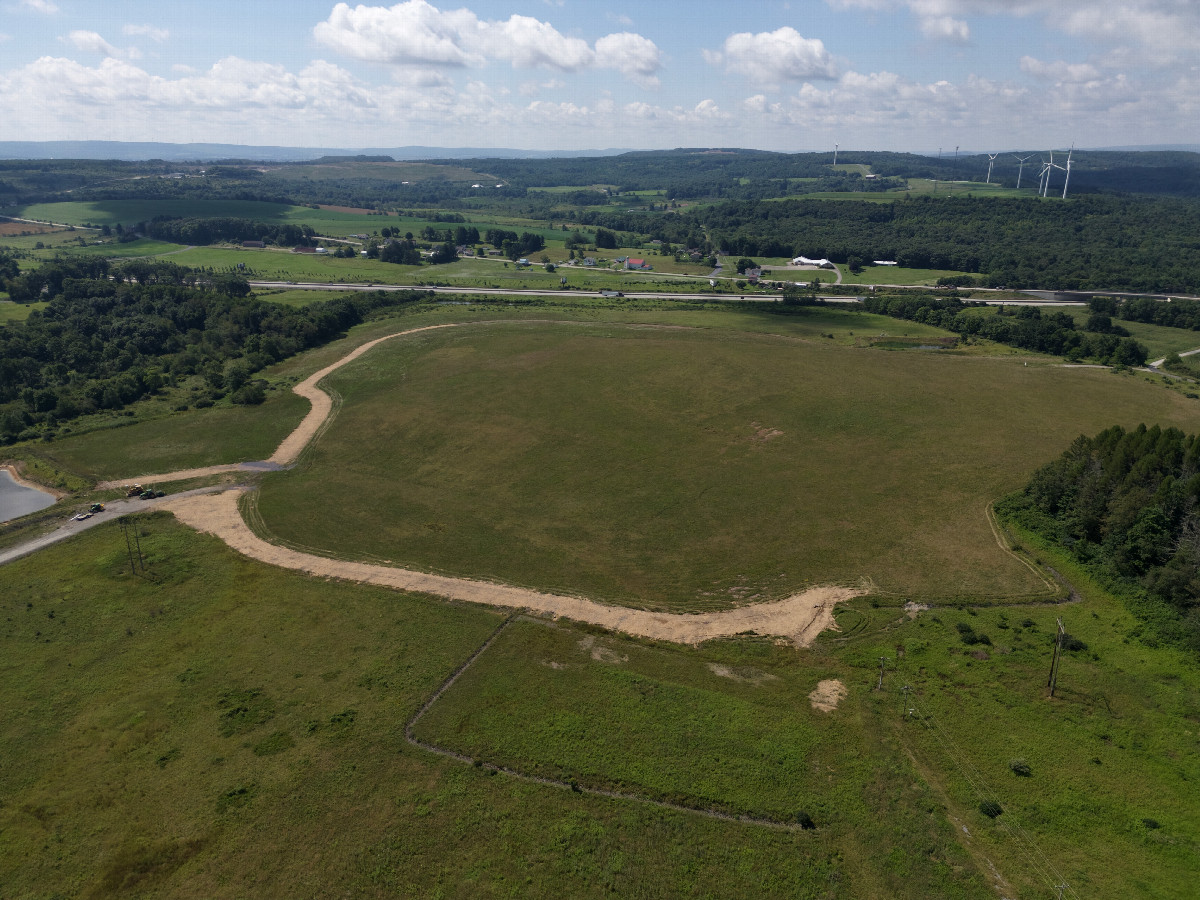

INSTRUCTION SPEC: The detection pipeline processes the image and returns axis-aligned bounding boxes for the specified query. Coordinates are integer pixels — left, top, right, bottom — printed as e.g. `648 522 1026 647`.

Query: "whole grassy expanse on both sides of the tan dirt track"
7 300 1200 900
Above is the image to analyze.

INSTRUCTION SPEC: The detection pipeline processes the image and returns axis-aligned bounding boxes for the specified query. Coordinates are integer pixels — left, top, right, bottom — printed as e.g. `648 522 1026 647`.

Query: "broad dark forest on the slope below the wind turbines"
676 197 1200 293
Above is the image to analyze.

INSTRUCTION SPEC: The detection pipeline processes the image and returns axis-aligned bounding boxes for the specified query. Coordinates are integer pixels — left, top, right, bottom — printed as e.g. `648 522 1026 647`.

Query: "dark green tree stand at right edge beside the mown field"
996 425 1200 649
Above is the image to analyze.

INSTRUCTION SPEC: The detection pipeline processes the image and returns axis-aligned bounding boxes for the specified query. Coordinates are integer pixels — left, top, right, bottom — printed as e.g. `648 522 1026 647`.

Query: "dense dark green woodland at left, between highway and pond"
0 259 424 443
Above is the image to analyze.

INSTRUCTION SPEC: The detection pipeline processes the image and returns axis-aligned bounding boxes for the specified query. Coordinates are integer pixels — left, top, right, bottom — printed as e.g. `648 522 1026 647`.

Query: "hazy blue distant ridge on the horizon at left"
0 140 626 162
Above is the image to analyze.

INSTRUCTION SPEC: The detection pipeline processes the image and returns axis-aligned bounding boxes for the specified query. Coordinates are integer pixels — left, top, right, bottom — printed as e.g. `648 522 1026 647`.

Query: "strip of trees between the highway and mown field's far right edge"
863 295 1147 366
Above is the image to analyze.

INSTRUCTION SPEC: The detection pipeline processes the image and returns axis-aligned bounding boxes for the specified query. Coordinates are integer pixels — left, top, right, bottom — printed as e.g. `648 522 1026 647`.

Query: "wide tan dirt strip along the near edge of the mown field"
162 491 863 647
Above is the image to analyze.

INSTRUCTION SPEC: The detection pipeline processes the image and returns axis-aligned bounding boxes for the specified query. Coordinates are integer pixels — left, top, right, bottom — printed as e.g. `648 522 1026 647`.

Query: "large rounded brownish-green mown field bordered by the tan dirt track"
259 311 1200 610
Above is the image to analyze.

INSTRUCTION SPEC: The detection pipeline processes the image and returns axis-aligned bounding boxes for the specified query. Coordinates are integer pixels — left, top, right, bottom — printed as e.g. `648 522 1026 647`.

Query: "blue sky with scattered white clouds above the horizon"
0 0 1200 151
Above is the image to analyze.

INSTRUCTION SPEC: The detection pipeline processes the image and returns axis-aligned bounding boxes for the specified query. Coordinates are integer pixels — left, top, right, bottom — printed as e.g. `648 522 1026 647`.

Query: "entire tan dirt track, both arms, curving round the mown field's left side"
26 323 865 647
